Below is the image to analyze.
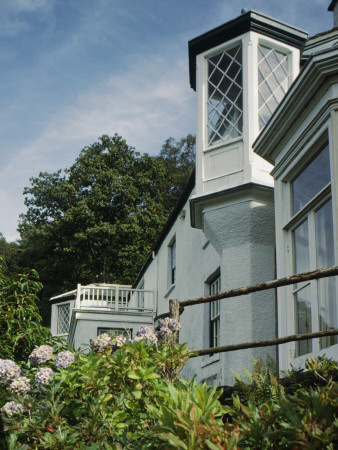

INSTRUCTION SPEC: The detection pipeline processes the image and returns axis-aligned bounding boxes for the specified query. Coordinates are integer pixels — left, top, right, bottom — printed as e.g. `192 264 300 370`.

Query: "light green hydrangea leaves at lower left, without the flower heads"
0 340 190 449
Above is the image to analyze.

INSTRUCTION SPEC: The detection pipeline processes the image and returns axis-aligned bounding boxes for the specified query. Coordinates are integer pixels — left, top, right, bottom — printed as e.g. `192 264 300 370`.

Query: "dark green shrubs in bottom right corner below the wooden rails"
225 357 338 450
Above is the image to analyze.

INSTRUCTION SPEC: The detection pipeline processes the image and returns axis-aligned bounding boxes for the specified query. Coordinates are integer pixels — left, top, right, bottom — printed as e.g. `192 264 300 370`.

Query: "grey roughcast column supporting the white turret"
204 201 276 385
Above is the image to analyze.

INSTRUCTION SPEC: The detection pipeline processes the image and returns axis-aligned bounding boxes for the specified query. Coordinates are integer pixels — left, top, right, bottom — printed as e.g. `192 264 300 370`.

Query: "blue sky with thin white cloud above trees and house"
0 0 333 241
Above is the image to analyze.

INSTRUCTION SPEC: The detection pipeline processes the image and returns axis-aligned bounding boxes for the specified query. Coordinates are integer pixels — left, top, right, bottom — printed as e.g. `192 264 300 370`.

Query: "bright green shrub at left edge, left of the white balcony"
0 259 51 361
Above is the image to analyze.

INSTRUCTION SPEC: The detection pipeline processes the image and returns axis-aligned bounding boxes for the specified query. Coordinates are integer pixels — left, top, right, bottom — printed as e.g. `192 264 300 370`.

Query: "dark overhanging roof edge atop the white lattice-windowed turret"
188 11 308 90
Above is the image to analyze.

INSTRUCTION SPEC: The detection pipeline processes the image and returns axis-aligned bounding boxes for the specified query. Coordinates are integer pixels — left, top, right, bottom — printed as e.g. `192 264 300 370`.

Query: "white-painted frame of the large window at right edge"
276 127 338 369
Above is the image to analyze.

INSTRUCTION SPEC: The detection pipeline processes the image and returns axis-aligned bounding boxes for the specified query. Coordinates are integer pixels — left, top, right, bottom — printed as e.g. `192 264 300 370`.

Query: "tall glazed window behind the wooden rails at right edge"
286 145 337 357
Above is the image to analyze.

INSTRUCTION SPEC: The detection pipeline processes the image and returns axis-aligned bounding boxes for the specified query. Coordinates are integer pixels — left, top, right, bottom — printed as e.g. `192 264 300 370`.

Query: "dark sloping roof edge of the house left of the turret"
133 169 195 288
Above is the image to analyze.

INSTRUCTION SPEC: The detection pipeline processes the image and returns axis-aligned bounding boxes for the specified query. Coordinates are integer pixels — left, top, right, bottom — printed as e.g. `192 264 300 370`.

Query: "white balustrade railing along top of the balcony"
75 284 155 313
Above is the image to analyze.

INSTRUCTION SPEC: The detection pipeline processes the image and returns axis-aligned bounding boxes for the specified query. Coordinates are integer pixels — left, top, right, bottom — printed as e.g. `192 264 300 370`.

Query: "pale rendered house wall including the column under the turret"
141 182 276 385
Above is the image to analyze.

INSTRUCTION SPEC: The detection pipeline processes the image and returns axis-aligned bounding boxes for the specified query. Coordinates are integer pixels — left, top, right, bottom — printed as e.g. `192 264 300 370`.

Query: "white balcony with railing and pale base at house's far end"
50 284 155 348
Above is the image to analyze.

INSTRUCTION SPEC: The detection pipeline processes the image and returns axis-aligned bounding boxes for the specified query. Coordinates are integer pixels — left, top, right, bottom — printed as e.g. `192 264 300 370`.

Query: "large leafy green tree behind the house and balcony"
19 135 194 316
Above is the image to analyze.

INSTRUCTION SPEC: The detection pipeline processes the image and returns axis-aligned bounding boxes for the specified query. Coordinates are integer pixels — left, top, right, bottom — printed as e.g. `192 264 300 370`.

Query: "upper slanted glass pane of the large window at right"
292 145 331 214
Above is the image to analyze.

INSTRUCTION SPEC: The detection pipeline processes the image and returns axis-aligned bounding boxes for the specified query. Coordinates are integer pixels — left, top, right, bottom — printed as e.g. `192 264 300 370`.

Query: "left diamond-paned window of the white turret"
208 45 243 145
